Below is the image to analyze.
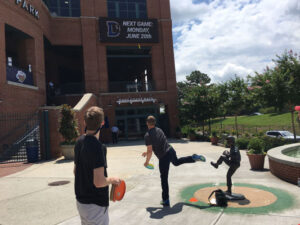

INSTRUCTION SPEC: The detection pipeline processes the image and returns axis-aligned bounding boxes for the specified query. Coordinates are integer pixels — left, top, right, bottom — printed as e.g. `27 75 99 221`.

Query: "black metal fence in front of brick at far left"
0 113 41 163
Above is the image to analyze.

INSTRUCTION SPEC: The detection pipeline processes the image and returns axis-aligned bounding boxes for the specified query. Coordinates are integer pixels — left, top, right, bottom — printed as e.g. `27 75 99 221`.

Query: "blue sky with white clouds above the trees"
170 0 300 82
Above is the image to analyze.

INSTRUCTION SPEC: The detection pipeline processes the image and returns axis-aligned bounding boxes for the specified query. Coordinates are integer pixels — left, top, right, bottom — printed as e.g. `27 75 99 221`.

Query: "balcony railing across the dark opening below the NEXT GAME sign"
109 81 155 92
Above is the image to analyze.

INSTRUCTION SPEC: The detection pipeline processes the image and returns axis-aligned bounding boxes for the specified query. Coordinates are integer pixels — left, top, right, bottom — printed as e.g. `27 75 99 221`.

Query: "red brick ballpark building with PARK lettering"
0 0 178 141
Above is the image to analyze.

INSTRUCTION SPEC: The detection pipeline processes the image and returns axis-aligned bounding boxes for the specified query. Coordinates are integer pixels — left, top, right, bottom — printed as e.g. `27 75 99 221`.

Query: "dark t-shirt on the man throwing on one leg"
144 127 171 159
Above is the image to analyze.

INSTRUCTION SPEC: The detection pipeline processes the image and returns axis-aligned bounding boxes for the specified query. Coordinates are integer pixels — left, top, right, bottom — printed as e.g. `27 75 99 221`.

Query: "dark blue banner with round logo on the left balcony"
6 66 33 85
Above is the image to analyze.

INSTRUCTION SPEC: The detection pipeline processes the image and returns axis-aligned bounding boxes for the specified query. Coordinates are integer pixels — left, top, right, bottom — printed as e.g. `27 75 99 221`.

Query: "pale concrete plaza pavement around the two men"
0 140 300 225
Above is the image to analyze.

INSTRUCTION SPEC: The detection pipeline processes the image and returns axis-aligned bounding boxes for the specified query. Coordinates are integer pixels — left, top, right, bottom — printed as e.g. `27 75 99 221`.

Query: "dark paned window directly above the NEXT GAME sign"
107 0 147 19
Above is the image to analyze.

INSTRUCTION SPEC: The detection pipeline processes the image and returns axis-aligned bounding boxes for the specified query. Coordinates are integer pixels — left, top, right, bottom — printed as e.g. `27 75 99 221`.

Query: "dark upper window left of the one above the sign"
43 0 80 17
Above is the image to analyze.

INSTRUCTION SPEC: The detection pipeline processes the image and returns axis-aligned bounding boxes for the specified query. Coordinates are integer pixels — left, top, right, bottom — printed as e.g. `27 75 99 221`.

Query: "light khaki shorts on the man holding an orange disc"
77 201 109 225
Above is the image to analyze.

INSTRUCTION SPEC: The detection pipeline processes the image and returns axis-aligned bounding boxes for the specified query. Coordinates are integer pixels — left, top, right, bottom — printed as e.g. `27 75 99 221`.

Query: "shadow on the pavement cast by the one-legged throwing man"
146 202 212 219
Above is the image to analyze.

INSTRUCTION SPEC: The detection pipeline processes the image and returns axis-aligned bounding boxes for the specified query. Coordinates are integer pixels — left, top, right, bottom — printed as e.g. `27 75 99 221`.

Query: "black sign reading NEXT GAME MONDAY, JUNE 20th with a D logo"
99 17 158 43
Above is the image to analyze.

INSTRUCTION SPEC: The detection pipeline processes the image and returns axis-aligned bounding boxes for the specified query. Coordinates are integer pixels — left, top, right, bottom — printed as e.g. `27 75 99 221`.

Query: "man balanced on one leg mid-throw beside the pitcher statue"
142 116 205 206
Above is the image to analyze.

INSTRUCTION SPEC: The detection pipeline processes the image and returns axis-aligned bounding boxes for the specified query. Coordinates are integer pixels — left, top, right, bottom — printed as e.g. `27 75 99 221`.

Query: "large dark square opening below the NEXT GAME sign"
106 46 155 92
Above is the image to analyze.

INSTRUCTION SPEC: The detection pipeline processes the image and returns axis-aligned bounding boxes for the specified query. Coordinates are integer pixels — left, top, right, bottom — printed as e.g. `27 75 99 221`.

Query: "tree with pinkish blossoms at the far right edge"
248 50 300 140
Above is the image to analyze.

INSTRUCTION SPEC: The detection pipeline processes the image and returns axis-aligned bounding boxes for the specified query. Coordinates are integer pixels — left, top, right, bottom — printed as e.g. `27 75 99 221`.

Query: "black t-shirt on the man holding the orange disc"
74 135 109 207
